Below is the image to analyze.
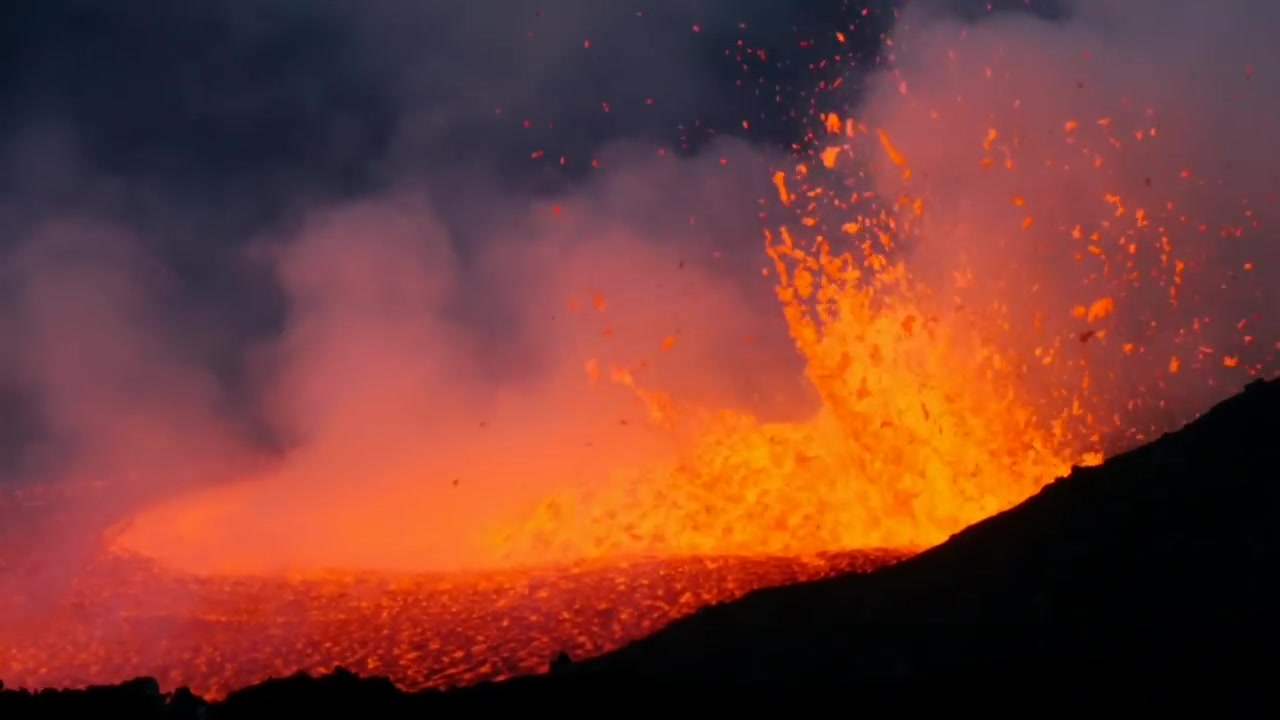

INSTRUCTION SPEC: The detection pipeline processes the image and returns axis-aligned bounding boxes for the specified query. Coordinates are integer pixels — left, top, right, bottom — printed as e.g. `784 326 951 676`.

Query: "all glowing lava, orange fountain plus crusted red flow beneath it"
0 119 1097 696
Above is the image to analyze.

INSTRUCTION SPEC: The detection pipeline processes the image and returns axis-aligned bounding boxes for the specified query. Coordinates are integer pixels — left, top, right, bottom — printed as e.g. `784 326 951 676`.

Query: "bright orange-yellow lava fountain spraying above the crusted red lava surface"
115 120 1097 574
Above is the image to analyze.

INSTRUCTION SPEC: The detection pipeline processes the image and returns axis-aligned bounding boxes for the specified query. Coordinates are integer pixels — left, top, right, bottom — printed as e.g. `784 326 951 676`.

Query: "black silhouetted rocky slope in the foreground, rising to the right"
0 380 1280 719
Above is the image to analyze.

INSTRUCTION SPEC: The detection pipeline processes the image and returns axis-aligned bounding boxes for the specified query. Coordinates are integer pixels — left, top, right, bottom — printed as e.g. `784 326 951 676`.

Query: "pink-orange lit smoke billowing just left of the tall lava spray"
112 147 808 571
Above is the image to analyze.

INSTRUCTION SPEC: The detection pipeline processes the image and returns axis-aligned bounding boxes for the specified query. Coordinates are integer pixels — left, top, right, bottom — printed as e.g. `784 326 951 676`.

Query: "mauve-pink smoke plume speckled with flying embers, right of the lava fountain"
860 0 1280 430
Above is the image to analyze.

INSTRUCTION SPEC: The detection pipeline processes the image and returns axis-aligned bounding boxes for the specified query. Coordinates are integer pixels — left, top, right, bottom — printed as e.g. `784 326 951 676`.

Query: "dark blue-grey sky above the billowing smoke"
0 0 1075 243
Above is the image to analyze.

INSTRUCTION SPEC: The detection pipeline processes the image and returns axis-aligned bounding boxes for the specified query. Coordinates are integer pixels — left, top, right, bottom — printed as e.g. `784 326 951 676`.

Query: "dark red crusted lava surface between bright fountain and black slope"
0 525 902 697
